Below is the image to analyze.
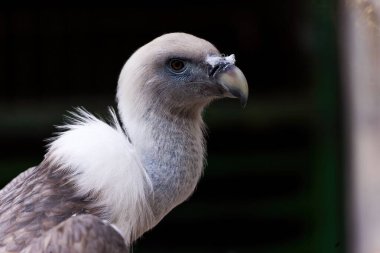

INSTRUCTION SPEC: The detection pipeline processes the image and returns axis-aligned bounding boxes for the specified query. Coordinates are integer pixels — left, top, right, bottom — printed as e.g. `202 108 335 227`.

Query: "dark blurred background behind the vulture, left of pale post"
0 0 345 253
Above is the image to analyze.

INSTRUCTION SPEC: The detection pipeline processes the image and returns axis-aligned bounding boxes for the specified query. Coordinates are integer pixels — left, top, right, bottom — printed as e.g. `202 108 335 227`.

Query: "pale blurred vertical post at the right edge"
342 0 380 253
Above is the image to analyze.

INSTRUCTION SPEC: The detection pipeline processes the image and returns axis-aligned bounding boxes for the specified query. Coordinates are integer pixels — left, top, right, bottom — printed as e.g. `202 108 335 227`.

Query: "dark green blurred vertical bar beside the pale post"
311 0 344 253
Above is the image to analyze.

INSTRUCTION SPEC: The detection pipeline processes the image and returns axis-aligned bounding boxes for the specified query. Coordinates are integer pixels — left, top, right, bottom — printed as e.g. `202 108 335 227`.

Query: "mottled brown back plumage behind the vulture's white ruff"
0 162 107 253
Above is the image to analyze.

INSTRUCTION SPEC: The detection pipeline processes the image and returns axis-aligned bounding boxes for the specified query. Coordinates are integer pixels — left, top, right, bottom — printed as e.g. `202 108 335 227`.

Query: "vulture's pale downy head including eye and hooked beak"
117 33 248 122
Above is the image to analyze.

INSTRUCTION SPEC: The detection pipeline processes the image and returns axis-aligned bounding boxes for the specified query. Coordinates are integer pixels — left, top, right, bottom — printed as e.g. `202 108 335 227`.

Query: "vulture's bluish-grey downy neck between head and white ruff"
121 106 205 222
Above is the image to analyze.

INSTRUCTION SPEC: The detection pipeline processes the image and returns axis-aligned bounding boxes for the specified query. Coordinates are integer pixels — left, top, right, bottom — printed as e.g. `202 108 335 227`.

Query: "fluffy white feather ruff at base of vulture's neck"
46 110 155 244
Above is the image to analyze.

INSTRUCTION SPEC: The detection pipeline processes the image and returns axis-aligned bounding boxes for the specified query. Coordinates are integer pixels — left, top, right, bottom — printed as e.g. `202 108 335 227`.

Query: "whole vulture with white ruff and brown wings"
0 33 248 253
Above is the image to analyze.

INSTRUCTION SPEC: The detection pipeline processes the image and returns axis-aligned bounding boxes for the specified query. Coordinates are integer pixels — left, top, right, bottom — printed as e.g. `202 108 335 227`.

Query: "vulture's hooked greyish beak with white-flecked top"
209 55 248 107
